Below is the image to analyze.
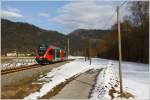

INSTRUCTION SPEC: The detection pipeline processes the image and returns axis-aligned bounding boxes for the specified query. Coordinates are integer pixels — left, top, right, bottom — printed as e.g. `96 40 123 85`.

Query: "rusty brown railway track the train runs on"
1 59 73 75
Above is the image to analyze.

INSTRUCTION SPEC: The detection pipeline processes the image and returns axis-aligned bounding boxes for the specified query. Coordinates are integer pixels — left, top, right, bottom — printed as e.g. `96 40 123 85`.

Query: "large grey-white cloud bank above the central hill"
49 1 118 30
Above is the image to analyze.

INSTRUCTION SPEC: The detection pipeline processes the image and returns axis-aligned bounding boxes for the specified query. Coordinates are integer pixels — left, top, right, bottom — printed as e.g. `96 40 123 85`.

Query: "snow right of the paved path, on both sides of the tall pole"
91 60 150 100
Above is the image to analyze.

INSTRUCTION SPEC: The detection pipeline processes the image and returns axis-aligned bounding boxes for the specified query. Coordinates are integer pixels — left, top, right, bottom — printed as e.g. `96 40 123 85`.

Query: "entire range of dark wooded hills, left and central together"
1 19 109 55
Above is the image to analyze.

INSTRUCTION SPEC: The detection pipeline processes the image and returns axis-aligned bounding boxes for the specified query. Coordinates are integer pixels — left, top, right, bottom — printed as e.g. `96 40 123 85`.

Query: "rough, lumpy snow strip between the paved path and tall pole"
90 62 118 100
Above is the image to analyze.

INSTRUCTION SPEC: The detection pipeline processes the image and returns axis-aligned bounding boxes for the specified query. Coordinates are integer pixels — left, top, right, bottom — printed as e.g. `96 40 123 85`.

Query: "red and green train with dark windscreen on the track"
36 44 66 64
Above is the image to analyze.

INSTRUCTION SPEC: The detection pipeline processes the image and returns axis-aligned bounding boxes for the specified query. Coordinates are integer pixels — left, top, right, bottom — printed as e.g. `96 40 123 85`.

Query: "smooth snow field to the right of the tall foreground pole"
122 62 150 100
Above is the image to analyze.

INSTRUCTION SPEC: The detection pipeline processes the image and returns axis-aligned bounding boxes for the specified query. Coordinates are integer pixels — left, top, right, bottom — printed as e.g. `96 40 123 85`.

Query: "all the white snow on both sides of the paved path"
24 57 149 100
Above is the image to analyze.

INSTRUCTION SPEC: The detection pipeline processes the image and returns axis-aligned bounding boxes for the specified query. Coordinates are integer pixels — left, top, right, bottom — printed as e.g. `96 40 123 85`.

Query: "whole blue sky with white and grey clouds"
1 1 129 34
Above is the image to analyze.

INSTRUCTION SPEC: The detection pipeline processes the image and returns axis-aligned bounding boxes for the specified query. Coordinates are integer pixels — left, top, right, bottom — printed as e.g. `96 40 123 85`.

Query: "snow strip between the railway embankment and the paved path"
24 58 109 100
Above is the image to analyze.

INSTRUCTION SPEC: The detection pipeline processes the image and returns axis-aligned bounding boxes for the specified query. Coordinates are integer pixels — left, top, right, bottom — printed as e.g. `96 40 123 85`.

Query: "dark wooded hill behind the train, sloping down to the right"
1 19 66 54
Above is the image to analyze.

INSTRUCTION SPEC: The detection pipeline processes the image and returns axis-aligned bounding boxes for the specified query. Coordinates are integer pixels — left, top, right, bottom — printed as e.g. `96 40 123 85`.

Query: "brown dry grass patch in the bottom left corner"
1 77 41 99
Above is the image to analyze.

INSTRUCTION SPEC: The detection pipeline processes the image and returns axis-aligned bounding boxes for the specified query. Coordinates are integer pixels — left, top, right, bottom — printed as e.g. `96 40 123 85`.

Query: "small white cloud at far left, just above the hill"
1 10 24 18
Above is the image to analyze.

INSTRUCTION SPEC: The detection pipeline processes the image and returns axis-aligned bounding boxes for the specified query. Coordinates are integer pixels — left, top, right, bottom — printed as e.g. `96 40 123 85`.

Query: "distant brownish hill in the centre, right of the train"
68 29 111 55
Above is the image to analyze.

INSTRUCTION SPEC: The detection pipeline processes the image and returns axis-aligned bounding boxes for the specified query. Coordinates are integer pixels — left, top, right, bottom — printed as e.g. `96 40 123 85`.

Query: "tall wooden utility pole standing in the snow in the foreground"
117 6 123 95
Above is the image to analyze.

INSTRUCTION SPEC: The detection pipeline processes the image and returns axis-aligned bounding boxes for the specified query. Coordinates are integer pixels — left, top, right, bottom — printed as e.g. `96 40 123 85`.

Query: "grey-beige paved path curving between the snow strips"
50 70 99 99
